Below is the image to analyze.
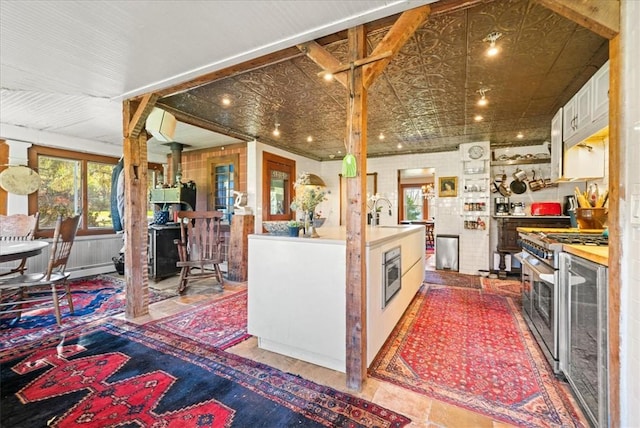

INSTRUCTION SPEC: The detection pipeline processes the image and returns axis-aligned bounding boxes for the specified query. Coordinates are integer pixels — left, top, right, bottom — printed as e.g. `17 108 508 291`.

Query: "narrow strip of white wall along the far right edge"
616 0 640 427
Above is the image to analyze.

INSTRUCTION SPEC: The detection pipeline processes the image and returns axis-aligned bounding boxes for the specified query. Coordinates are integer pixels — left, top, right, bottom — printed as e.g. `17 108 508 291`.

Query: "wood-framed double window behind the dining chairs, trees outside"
29 146 158 237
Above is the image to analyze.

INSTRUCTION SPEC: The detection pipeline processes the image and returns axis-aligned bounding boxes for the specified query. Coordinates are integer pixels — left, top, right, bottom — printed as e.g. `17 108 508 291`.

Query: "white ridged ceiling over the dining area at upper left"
0 0 432 152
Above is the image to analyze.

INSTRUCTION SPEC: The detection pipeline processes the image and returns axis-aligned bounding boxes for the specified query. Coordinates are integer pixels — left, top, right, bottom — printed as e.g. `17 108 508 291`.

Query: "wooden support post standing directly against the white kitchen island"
346 26 367 391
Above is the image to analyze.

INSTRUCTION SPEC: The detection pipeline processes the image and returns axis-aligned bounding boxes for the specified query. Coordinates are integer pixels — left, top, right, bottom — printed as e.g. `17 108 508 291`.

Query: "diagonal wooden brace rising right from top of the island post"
363 5 431 88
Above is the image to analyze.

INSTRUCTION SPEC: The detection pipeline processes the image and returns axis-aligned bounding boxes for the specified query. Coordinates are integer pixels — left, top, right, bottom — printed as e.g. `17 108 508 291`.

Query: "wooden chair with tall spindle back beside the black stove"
174 211 224 293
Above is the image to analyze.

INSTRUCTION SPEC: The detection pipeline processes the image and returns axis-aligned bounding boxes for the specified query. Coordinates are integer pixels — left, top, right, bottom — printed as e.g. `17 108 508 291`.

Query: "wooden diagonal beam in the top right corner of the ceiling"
537 0 620 40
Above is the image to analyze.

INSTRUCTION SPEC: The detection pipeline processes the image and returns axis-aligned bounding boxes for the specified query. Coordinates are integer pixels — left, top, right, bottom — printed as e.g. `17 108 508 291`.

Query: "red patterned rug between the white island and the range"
369 286 583 427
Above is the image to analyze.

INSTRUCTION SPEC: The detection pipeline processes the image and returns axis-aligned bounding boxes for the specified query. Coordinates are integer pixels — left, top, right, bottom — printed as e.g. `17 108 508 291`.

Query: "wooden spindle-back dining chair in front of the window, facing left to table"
0 215 81 325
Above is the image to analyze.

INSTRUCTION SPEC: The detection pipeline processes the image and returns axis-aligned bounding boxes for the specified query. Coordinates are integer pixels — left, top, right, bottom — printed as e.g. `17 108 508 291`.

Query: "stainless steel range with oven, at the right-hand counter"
519 232 608 374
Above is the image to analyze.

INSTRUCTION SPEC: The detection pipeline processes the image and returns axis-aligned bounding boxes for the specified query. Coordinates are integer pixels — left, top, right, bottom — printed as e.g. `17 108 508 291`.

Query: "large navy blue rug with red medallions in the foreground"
0 320 411 428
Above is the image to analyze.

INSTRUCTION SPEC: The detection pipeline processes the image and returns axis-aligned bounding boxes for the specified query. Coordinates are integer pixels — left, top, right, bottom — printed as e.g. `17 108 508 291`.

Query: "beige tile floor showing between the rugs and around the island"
116 256 586 428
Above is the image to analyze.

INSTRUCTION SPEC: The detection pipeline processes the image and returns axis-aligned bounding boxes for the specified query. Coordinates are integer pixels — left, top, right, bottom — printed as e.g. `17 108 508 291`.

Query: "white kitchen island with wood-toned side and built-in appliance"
248 225 425 372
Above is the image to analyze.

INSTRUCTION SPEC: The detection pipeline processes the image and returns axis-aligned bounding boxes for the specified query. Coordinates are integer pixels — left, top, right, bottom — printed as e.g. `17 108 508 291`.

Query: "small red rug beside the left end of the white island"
146 290 251 349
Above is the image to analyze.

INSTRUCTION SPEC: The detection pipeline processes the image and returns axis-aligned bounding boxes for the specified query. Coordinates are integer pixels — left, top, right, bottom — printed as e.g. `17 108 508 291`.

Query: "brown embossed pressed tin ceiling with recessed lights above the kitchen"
158 0 608 160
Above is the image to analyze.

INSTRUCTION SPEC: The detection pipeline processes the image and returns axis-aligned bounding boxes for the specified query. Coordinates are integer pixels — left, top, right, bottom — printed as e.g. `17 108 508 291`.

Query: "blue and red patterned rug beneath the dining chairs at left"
0 275 176 349
